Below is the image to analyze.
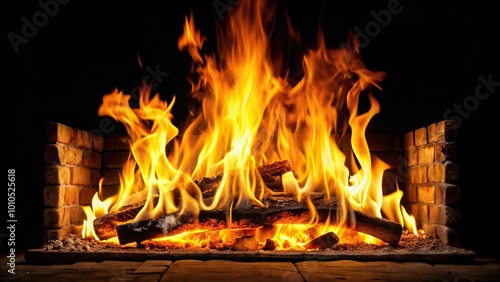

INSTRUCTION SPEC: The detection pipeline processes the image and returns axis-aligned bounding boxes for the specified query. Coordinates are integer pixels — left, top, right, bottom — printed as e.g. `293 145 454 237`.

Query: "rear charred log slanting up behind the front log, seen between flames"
93 160 293 240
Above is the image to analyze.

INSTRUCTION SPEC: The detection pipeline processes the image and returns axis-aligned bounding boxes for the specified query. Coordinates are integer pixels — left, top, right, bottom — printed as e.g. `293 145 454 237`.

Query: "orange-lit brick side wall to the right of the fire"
403 120 461 247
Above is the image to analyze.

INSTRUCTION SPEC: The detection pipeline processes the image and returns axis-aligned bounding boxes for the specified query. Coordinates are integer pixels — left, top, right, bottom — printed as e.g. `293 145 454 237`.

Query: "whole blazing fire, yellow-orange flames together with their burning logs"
83 1 417 250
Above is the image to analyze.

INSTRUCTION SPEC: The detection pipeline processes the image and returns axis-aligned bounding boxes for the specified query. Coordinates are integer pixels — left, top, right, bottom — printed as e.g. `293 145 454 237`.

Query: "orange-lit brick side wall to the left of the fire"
43 122 104 240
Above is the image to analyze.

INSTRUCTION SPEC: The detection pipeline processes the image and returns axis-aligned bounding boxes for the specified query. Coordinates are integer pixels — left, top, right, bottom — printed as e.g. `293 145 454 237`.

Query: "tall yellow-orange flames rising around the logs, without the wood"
83 1 416 249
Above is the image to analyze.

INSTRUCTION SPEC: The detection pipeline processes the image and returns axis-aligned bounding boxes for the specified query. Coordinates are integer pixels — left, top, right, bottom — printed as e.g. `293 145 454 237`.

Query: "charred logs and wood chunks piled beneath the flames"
93 161 403 249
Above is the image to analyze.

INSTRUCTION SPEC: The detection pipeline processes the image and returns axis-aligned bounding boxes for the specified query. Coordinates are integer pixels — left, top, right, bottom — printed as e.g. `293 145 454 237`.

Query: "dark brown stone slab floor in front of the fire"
0 253 500 282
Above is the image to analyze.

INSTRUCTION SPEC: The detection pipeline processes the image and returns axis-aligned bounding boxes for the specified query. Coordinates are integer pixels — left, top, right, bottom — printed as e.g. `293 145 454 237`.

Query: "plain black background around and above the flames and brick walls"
0 0 500 255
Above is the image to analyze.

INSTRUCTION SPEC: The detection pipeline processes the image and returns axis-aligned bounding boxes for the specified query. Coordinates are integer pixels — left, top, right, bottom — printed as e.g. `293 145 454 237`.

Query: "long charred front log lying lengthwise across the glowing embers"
116 194 403 247
